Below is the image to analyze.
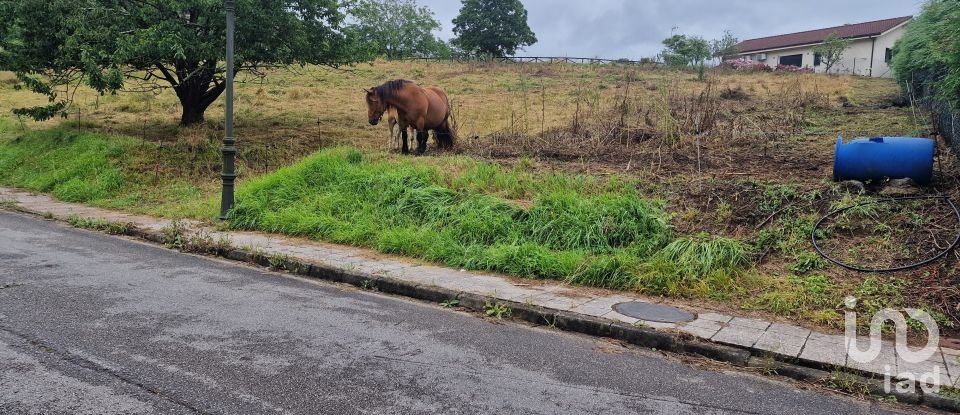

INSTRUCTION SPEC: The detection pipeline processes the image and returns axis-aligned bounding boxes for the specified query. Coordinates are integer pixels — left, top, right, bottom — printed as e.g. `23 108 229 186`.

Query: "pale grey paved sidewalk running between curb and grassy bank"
0 187 960 386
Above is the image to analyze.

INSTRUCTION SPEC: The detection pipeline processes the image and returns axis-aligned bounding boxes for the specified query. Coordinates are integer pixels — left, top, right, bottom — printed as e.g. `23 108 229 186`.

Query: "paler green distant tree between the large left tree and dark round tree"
351 0 450 59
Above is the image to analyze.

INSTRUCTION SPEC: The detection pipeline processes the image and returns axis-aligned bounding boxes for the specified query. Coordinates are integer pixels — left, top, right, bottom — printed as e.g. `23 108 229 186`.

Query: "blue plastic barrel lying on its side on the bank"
833 137 936 184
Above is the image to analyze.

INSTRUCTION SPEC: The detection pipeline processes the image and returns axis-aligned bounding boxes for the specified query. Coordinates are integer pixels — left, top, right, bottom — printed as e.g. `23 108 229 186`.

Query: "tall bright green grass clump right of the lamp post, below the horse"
231 148 688 288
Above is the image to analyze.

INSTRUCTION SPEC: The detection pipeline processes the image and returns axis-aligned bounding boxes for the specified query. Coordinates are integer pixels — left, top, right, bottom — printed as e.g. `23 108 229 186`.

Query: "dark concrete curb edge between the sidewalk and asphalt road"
14 210 960 413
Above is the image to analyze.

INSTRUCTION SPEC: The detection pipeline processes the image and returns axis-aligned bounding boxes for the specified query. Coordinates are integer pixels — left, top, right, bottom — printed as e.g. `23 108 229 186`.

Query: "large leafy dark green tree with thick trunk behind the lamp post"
0 0 365 125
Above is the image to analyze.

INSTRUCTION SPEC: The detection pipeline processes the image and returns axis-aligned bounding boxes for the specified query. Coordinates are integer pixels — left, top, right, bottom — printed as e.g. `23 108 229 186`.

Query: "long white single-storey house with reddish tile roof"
737 16 913 78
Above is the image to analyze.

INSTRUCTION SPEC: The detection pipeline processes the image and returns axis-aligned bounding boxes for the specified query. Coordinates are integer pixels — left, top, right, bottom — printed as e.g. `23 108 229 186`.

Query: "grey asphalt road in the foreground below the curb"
0 211 928 414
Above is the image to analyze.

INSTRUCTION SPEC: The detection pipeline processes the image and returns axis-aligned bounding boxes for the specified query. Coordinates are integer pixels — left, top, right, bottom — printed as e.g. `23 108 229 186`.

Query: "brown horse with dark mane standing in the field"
364 80 457 155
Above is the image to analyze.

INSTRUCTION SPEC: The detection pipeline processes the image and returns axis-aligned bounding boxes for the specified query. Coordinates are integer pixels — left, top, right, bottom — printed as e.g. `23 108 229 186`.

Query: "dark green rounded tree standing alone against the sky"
452 0 537 56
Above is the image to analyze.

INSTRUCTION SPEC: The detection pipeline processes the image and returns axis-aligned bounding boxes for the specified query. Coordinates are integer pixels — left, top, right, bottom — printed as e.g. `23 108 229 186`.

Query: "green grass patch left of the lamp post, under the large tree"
0 122 217 218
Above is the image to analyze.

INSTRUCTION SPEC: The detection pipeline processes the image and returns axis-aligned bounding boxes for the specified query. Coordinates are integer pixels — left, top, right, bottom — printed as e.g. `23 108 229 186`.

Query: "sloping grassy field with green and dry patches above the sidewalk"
0 63 945 334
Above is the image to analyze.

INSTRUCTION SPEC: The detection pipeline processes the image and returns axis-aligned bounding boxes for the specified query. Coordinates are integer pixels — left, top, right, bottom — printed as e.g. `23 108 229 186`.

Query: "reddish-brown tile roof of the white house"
737 16 913 53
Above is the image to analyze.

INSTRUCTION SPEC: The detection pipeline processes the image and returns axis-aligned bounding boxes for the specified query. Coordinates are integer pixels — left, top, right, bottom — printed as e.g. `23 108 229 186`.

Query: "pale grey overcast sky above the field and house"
418 0 922 59
